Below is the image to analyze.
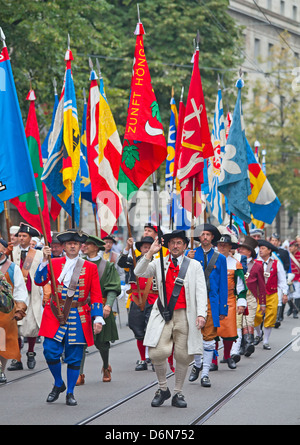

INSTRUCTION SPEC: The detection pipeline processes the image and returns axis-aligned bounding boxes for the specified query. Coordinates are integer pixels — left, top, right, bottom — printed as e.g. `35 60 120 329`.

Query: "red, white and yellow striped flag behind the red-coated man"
87 70 122 237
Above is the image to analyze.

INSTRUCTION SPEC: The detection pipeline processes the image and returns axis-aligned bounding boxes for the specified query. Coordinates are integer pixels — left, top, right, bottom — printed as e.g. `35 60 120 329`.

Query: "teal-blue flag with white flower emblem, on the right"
218 79 251 224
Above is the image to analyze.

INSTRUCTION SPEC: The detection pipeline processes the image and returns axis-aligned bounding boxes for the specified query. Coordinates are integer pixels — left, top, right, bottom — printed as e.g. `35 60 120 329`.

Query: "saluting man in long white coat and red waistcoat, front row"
134 230 207 408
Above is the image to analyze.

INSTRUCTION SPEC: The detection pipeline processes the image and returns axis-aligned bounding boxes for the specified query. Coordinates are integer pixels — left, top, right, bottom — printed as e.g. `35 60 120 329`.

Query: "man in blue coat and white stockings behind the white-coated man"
187 223 228 387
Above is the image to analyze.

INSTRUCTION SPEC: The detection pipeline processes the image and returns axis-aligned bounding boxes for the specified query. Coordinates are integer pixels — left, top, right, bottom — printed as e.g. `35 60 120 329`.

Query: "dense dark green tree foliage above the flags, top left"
0 0 243 140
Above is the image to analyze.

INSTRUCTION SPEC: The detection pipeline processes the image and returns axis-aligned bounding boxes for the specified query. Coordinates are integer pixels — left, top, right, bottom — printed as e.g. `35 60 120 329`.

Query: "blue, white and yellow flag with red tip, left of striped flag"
42 50 80 225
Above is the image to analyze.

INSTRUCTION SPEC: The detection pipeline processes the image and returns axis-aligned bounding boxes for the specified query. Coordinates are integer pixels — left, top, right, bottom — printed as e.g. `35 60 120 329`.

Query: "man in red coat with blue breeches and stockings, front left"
35 229 104 406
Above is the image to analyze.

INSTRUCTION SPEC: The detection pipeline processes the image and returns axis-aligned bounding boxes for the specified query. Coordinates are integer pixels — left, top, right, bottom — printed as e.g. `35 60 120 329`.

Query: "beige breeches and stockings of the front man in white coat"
149 309 193 394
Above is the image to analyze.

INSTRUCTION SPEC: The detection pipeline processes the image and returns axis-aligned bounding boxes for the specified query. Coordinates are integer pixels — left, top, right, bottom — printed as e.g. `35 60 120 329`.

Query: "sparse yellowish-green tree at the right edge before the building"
245 34 300 216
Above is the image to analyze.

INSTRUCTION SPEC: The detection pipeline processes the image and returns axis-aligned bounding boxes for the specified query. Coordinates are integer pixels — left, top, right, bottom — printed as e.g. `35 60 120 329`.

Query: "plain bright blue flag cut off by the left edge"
0 39 36 202
